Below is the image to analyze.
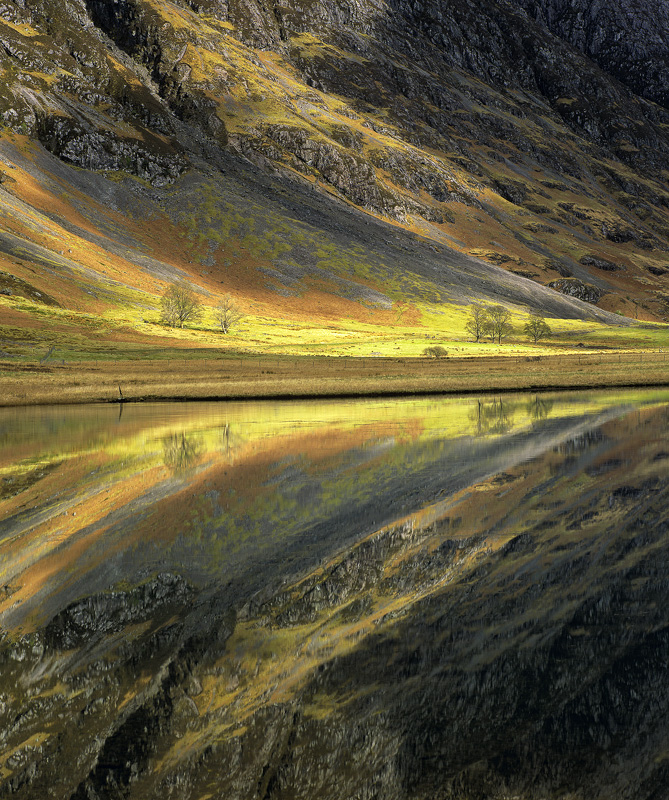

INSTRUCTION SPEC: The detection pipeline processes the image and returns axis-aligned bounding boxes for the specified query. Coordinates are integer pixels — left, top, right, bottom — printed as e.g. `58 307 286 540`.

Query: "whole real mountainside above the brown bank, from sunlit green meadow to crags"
0 0 669 360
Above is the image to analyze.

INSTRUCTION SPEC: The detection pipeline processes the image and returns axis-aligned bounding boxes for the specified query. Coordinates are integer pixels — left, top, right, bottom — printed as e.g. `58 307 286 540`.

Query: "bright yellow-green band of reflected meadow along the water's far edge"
0 390 663 484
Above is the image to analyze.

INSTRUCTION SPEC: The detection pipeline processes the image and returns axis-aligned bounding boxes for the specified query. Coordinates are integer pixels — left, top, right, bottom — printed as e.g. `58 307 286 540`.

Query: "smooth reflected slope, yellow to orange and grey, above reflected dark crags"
1 393 663 632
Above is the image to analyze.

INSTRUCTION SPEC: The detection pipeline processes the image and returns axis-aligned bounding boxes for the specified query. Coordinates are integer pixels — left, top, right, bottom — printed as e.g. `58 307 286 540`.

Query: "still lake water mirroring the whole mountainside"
0 390 669 798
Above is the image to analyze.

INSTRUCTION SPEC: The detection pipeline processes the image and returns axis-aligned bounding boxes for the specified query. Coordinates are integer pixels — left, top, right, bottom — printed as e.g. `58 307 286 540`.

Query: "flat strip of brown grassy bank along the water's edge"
0 351 669 406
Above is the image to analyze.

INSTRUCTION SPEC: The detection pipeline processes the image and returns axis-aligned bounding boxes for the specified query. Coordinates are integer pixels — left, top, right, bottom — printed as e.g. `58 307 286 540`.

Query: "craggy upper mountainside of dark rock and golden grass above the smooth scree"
0 0 669 314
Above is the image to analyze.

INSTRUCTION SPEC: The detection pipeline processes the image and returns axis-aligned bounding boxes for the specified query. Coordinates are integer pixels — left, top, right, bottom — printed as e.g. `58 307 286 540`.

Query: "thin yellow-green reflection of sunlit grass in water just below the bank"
0 389 664 466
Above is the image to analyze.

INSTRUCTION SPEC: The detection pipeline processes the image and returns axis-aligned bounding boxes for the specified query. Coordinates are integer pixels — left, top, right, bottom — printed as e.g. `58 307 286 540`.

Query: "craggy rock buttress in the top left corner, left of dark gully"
0 0 185 185
